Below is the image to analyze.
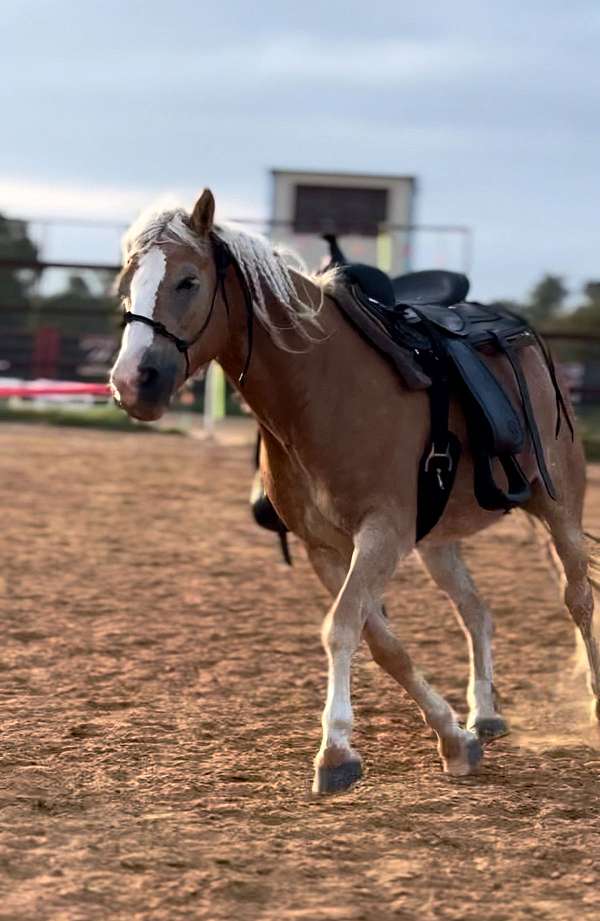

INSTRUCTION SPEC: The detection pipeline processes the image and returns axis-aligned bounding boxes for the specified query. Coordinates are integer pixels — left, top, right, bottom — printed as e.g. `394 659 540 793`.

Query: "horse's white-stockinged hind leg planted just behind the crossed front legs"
418 543 508 741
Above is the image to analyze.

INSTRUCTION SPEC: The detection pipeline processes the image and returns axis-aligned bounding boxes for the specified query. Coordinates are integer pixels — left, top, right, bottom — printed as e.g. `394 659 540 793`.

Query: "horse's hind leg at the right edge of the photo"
527 489 600 718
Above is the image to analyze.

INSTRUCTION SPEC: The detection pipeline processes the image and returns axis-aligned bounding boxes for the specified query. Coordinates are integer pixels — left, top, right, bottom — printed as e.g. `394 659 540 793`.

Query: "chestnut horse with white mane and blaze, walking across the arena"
110 189 600 793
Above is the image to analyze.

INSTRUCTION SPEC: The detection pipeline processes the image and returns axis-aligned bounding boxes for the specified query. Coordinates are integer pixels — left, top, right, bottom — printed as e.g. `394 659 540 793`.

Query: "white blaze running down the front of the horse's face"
112 246 167 388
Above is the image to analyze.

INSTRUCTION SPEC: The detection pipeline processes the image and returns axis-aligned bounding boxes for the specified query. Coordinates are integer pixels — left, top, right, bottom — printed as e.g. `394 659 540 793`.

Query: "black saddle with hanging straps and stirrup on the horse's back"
331 274 573 540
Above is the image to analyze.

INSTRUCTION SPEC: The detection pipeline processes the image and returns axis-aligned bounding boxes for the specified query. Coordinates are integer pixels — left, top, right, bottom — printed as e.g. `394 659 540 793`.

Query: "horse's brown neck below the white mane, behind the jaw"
219 278 340 443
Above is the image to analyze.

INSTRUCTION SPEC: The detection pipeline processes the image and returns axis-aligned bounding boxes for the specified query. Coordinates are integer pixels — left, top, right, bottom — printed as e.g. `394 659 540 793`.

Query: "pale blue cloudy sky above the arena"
0 0 600 303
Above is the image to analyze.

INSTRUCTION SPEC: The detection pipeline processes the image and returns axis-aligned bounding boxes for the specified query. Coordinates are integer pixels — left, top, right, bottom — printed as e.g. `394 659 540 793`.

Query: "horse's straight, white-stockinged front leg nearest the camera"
311 521 409 793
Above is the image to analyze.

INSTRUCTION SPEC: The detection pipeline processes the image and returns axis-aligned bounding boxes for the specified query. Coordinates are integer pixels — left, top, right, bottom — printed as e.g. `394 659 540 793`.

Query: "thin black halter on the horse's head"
123 234 254 386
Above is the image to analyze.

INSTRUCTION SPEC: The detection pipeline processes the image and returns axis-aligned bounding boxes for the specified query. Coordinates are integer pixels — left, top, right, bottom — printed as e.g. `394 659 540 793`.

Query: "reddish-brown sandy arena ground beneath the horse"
0 425 600 921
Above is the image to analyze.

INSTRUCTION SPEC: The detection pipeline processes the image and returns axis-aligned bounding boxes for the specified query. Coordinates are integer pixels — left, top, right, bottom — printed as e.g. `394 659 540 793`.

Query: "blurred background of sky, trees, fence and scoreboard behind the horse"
0 0 600 442
